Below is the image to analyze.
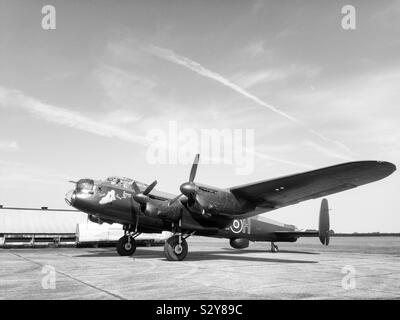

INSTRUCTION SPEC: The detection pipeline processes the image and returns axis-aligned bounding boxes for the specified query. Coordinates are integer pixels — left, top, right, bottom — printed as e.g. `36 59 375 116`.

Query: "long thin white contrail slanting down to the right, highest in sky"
145 45 352 159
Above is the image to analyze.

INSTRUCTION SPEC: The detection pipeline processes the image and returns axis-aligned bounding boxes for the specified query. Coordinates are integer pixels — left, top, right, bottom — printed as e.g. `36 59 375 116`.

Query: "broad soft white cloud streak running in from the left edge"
0 86 147 144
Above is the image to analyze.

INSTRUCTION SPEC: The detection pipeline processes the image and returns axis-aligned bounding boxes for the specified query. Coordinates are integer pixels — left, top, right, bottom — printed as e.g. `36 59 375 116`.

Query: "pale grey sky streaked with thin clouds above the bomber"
0 0 400 232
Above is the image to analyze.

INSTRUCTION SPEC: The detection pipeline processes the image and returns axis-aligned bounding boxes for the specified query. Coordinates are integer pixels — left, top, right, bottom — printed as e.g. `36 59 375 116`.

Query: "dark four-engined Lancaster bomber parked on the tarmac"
65 154 396 261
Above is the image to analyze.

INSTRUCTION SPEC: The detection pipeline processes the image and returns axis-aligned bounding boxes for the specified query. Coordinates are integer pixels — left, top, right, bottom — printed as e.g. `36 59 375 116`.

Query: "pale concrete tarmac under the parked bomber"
0 237 400 300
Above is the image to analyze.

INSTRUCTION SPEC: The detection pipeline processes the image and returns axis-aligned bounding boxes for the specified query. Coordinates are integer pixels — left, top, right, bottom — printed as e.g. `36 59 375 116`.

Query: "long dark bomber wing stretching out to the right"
230 161 396 211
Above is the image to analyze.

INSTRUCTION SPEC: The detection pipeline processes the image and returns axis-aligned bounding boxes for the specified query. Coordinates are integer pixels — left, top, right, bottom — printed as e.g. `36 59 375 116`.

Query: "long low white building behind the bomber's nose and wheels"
0 208 171 247
